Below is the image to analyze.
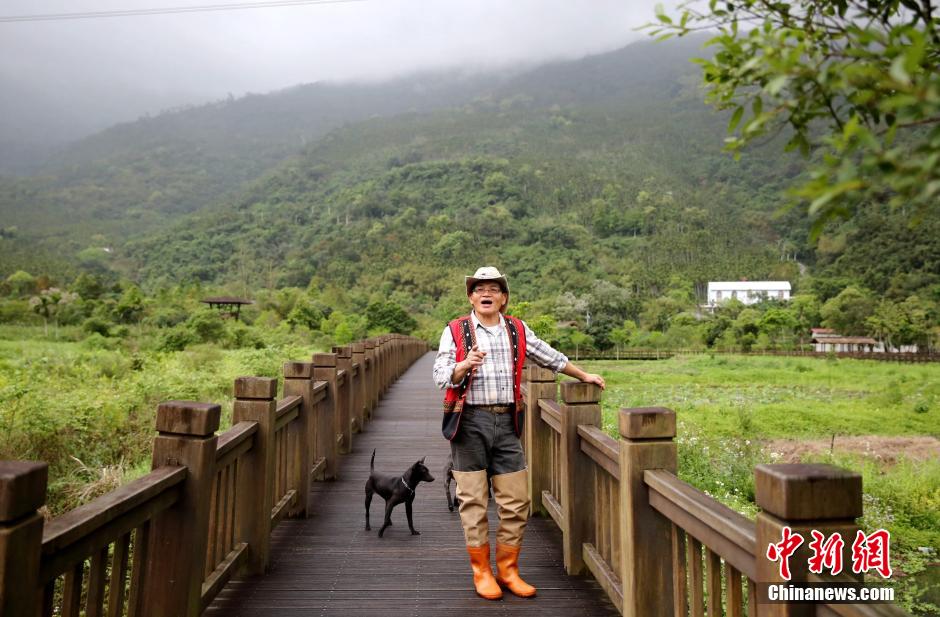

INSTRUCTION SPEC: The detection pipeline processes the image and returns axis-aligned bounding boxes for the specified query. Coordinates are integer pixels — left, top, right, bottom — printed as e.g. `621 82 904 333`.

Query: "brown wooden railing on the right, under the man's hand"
523 366 906 617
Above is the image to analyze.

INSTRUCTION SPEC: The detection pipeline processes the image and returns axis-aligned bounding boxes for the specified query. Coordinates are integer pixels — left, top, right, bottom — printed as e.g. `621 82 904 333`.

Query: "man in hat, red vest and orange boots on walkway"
434 266 604 600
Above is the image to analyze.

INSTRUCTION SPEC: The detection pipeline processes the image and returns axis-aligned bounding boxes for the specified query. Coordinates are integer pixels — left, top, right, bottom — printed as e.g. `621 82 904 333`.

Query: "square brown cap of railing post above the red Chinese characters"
754 464 862 521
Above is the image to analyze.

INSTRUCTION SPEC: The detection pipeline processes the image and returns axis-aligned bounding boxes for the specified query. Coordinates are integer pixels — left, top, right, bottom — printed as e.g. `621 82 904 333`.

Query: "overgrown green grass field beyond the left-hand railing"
0 326 315 514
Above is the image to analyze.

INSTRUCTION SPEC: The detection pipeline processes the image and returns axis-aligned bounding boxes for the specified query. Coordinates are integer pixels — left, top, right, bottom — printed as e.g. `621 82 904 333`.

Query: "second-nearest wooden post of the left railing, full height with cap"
142 401 221 617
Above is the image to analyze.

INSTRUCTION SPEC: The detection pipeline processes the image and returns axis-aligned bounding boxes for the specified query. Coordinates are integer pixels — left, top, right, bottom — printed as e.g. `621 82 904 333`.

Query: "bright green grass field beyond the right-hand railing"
583 355 940 615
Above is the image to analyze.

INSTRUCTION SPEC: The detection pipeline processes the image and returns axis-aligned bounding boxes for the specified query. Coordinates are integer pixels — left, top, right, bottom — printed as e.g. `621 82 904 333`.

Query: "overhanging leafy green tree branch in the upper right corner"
646 0 940 235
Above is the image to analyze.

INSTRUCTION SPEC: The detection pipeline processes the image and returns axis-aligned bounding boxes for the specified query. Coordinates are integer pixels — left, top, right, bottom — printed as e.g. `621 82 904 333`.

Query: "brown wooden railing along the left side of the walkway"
0 335 427 617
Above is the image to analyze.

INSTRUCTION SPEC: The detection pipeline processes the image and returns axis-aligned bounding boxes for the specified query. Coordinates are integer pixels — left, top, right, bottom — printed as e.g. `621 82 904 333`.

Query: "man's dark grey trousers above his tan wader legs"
450 405 525 476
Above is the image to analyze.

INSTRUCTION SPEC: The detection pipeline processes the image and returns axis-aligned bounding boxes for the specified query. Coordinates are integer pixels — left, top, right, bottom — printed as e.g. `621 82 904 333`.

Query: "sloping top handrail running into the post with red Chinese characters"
643 469 757 580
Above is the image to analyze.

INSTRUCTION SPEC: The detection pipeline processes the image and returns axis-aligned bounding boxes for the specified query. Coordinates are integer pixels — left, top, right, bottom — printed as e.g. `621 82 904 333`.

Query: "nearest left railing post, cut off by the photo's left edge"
0 461 49 617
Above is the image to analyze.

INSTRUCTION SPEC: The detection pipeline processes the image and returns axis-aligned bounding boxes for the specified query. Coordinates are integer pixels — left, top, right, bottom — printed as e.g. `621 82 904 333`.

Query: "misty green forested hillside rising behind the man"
0 38 940 347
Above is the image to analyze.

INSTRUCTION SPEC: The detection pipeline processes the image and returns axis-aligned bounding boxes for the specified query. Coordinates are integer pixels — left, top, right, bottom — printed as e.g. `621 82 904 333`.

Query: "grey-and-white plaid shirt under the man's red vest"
434 312 568 405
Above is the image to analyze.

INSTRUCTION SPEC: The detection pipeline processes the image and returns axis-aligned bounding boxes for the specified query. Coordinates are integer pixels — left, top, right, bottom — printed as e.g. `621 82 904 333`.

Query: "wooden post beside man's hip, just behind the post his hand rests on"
525 364 558 516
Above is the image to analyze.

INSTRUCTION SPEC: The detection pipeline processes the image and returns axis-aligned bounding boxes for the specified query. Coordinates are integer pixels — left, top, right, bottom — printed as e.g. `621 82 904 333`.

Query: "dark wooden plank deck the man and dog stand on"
205 353 618 617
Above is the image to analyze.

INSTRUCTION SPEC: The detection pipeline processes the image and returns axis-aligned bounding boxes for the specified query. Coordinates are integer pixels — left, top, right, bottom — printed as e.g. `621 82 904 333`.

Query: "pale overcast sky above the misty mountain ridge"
0 0 655 141
